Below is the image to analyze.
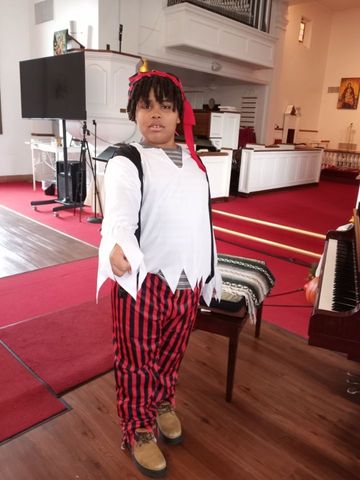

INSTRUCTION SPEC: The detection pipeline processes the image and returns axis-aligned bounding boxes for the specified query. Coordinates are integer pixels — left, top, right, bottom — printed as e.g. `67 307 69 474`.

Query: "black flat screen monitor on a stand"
20 52 86 120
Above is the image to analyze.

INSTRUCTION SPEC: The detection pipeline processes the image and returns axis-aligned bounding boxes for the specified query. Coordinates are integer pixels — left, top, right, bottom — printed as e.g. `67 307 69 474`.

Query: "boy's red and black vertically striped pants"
112 274 201 446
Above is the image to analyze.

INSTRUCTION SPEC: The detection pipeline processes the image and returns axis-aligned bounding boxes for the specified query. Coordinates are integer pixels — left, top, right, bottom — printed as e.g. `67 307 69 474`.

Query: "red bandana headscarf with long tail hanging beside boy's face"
129 70 206 172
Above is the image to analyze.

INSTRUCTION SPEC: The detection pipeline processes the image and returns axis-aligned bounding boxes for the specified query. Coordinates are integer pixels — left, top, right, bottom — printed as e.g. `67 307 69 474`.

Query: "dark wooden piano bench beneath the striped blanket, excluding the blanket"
194 301 262 402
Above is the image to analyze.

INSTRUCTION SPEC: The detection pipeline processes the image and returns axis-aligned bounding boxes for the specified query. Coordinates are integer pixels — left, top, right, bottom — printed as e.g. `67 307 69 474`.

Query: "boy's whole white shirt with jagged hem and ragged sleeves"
98 143 221 303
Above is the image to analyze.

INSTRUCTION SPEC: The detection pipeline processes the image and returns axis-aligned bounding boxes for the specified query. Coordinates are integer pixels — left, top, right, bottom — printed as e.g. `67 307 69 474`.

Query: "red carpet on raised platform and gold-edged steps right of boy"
213 181 358 264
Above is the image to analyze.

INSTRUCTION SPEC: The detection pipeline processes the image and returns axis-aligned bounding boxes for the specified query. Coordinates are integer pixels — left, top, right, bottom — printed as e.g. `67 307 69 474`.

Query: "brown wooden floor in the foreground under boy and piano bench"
0 208 360 480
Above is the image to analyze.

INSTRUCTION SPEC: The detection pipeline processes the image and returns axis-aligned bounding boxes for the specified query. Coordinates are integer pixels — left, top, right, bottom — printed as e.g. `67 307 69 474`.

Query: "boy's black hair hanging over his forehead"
127 74 183 122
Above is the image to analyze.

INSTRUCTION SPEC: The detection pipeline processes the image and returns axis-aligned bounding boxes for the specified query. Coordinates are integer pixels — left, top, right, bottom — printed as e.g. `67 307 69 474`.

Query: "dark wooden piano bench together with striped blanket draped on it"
194 254 275 402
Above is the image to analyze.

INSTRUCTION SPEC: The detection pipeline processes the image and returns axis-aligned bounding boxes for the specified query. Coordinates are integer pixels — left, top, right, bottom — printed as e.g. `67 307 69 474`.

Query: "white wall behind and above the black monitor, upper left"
0 0 98 177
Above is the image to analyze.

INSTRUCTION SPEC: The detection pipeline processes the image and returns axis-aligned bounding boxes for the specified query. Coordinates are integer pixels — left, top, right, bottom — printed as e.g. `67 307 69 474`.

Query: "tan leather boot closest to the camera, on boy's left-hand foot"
132 428 166 478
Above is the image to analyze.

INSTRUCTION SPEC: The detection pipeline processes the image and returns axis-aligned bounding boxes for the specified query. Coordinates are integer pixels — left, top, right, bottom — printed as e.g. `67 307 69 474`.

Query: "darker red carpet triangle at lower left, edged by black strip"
0 345 66 442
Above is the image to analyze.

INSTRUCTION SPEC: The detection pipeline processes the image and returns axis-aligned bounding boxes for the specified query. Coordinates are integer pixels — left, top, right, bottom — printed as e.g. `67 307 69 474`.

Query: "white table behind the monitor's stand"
29 140 80 190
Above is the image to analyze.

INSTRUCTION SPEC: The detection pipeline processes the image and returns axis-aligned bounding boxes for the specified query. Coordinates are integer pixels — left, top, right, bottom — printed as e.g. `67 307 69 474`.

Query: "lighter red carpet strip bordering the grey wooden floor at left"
0 257 109 329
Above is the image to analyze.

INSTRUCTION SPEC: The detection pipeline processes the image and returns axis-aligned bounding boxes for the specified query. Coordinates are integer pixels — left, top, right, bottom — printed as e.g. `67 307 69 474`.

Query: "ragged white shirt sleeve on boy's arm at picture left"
97 156 144 297
